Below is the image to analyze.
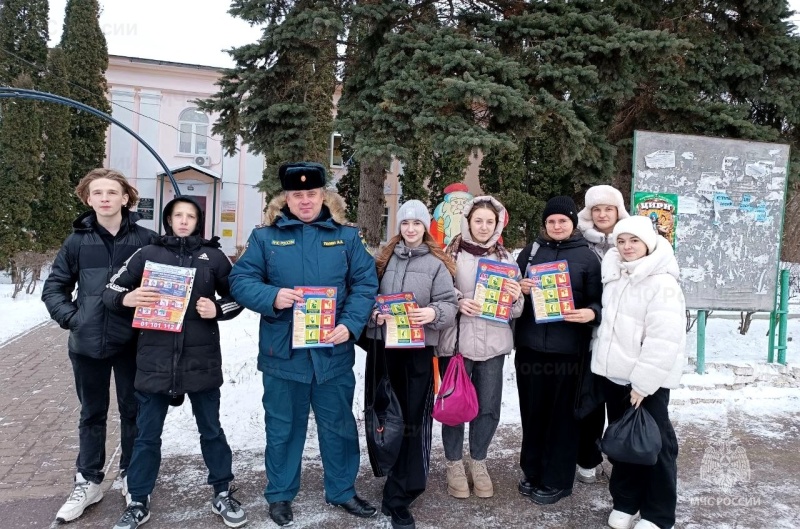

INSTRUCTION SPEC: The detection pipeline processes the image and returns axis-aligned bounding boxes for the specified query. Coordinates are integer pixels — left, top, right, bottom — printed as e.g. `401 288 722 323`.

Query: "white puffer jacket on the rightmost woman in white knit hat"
592 236 686 396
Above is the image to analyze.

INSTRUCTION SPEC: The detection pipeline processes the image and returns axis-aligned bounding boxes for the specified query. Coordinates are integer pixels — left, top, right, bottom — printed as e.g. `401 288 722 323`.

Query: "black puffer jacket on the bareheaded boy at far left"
42 208 156 358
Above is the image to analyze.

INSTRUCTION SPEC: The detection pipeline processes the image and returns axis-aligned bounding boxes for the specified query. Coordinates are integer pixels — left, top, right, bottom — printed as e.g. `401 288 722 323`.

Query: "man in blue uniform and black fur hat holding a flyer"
230 162 378 525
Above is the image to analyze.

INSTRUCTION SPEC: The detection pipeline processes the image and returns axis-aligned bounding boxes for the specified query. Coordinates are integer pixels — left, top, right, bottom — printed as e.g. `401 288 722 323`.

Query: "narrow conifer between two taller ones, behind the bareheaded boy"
31 48 78 252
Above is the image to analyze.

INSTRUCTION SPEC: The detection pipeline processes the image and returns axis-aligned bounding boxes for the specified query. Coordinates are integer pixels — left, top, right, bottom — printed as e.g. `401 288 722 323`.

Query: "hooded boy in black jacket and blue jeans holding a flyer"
103 197 247 529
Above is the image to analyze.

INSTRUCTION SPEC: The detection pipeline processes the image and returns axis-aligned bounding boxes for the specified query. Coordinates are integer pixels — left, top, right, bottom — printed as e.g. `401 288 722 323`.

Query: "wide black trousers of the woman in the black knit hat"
514 347 580 489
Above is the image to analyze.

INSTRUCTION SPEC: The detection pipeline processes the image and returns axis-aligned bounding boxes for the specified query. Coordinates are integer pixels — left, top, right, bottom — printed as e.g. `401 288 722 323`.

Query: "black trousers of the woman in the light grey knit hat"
377 347 433 509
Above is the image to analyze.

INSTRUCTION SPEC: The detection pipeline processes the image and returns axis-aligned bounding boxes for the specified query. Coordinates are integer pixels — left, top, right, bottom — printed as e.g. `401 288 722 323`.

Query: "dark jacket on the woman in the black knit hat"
514 234 603 355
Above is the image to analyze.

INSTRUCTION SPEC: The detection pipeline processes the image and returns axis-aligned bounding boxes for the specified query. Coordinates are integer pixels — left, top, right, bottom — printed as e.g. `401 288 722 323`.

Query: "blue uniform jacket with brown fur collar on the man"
230 192 378 383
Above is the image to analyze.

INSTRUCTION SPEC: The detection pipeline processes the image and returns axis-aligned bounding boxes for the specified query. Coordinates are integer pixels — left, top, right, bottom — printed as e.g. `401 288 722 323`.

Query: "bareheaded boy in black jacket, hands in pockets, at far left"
42 168 155 522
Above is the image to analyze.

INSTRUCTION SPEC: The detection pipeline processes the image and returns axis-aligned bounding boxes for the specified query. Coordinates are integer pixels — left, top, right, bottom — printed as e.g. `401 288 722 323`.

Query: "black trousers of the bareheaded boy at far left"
69 347 139 483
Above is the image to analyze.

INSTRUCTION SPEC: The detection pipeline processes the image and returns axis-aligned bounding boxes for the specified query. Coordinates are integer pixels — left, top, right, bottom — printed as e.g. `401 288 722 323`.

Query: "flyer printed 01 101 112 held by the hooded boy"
133 261 195 332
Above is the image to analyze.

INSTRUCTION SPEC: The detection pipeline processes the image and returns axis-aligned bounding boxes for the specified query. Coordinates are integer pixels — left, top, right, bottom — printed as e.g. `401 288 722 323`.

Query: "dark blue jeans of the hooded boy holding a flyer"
128 389 233 503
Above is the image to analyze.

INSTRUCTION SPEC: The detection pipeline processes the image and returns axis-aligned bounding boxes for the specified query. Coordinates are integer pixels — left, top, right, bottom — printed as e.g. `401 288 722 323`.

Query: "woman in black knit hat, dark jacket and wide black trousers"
514 197 603 504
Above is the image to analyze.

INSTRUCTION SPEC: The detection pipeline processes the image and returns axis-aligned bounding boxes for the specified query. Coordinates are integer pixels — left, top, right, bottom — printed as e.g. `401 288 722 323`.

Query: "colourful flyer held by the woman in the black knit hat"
528 261 575 323
